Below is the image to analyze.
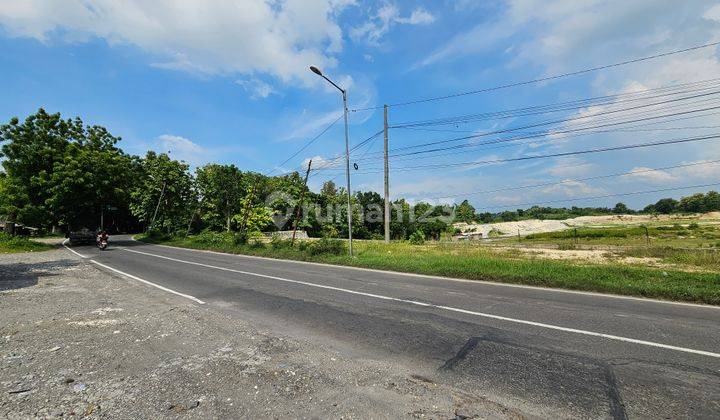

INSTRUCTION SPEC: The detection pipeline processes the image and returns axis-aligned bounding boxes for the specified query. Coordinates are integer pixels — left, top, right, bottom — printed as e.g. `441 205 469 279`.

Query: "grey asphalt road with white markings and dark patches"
66 237 720 418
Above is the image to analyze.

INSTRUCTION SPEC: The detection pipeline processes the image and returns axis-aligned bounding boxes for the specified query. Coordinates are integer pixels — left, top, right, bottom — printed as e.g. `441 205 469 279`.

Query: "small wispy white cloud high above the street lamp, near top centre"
350 4 435 45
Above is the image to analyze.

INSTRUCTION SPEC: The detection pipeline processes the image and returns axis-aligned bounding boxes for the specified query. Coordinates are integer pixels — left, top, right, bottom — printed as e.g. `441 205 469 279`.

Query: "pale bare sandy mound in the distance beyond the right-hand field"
454 212 720 238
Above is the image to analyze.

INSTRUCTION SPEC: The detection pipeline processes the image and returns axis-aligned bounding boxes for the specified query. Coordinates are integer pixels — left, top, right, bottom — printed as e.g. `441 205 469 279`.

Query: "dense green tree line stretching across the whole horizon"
0 109 720 239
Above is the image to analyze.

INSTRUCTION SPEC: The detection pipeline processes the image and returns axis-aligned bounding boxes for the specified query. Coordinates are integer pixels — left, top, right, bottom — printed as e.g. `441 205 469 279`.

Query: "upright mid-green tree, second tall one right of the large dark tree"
196 164 246 232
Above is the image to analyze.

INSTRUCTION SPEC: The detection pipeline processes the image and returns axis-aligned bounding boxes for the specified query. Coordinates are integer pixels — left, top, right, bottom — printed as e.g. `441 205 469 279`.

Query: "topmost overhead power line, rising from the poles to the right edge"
352 42 720 112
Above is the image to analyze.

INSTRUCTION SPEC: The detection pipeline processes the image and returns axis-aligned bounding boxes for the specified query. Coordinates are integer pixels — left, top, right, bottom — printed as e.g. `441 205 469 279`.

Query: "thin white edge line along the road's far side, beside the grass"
130 236 720 310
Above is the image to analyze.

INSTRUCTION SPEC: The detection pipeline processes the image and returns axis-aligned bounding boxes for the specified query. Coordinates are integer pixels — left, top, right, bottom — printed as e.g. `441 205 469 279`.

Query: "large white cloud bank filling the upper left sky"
0 0 353 86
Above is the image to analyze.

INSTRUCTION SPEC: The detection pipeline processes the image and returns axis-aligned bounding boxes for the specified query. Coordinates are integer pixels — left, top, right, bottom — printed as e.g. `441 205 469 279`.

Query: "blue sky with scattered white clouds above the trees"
0 0 720 211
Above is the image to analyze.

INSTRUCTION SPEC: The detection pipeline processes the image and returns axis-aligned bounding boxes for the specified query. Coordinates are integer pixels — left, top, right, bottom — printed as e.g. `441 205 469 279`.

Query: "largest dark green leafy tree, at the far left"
0 108 142 228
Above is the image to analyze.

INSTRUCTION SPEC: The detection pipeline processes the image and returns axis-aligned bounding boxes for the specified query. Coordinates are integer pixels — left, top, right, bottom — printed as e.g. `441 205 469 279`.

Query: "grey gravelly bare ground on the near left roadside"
0 249 520 418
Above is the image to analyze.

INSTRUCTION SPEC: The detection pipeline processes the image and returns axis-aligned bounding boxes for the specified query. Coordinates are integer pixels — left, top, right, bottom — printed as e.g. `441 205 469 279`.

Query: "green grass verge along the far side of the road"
137 234 720 305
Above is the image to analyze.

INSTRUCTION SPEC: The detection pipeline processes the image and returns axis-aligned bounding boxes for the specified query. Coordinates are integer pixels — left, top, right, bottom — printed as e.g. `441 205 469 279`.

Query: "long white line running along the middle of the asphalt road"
123 248 720 358
